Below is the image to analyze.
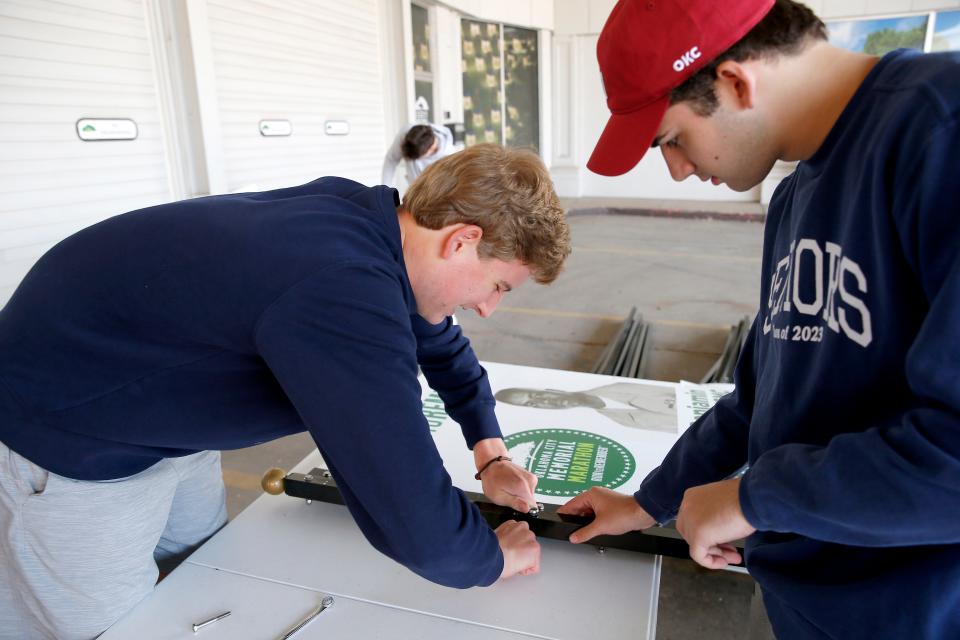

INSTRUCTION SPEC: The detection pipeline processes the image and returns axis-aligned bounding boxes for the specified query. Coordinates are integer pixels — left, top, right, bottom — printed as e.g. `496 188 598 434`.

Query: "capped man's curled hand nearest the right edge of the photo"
677 478 756 569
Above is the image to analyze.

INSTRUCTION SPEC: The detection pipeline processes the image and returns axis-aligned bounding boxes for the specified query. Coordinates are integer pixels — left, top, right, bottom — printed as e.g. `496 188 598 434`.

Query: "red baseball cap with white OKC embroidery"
587 0 774 176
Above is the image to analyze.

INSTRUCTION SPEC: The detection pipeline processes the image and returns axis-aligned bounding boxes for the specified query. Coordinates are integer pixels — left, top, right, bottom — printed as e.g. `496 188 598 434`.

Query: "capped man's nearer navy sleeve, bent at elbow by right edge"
740 122 960 546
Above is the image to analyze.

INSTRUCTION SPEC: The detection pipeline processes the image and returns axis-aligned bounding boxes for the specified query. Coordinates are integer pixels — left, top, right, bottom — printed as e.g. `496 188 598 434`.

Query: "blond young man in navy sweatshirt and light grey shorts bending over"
0 145 570 639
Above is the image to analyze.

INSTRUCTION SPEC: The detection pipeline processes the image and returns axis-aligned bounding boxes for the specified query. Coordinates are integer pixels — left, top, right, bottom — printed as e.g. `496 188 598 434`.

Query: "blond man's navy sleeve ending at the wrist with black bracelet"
412 315 502 449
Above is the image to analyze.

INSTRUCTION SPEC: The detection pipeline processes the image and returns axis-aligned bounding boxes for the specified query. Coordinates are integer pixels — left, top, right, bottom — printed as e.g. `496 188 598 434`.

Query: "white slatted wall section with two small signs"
201 0 385 191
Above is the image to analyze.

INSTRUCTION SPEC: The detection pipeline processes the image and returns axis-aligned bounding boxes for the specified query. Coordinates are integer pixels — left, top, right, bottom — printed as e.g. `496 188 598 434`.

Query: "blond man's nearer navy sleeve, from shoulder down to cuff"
255 264 503 588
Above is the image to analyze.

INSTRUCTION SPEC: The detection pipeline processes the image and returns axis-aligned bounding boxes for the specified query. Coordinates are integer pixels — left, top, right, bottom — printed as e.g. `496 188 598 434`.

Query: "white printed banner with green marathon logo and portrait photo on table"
421 363 733 504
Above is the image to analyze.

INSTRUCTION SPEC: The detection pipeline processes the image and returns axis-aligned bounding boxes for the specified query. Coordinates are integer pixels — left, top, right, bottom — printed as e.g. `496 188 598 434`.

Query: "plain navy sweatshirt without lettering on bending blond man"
0 178 503 587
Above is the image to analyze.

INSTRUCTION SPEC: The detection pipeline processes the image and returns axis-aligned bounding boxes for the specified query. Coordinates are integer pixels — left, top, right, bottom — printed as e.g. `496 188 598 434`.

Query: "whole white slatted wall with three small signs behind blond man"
0 0 405 307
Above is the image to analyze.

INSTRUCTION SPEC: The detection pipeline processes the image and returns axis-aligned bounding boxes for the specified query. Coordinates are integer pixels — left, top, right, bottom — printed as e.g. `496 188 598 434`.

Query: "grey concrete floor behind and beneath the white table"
223 208 763 640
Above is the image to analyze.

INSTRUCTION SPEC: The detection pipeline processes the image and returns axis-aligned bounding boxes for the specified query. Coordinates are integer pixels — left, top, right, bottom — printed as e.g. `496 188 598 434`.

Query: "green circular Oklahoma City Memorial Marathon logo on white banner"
503 429 637 496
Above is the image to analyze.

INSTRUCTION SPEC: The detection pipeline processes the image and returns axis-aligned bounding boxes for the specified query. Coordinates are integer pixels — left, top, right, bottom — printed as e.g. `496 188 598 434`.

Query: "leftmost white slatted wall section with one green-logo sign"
0 0 171 307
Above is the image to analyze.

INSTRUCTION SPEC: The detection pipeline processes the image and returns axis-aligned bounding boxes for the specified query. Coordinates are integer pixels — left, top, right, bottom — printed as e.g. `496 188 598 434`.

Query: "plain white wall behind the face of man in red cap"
551 0 960 202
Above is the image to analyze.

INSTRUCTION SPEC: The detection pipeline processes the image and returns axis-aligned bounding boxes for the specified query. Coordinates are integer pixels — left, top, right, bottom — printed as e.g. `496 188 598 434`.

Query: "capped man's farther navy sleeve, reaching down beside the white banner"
634 319 757 524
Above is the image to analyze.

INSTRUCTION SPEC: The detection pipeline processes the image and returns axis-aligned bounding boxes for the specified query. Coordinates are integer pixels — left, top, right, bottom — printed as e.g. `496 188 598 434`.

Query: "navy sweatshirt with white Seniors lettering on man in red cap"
636 51 960 639
